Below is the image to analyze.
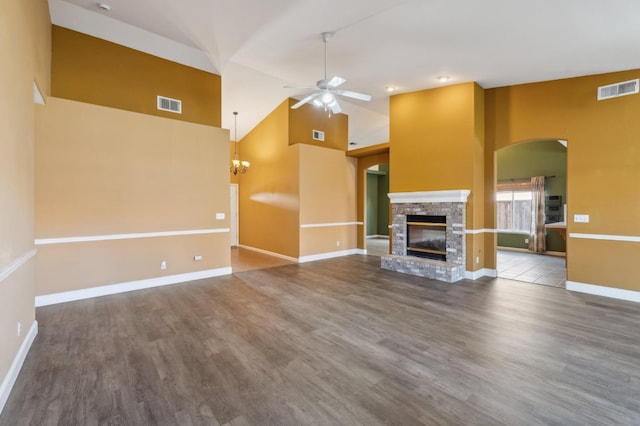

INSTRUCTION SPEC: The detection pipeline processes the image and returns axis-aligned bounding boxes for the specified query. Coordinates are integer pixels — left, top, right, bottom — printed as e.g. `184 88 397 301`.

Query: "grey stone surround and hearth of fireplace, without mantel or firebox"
381 202 466 283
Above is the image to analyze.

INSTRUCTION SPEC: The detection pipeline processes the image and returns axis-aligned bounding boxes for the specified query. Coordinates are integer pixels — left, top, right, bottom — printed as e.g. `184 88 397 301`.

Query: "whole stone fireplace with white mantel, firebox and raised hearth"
381 190 470 283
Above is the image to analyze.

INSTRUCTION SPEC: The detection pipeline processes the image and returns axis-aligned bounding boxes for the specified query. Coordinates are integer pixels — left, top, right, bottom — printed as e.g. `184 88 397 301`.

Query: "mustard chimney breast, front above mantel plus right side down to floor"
389 83 485 271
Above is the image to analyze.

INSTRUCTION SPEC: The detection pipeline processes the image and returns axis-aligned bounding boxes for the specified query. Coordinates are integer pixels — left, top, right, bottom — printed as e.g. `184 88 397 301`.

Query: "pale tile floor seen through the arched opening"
498 250 567 288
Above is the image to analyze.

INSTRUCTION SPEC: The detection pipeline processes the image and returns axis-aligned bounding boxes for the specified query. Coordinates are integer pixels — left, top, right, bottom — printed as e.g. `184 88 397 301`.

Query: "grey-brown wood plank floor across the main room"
0 255 640 426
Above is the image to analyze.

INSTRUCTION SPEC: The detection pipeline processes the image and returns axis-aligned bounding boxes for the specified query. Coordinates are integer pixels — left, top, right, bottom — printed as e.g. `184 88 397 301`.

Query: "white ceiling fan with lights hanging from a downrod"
284 32 371 114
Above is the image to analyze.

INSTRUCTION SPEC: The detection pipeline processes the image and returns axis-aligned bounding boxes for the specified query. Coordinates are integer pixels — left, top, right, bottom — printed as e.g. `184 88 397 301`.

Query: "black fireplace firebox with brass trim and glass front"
407 215 447 261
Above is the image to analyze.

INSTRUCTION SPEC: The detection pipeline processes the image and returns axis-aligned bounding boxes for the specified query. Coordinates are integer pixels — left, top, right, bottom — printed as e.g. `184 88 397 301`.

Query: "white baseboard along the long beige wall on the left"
36 267 231 307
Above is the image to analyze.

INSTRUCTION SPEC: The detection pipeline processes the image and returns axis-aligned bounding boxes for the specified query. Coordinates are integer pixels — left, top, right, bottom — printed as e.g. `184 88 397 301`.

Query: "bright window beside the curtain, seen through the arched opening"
496 183 533 233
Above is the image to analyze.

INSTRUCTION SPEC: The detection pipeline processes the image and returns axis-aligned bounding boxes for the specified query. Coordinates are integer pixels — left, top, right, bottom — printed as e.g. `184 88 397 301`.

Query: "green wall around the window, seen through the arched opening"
496 140 567 252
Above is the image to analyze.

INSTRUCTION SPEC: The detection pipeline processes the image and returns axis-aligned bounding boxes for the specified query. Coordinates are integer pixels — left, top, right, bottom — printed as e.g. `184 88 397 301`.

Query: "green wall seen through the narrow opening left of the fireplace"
367 164 389 235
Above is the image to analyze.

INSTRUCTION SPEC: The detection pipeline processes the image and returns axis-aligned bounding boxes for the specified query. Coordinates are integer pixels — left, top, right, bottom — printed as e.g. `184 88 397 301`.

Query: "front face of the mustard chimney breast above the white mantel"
389 83 475 192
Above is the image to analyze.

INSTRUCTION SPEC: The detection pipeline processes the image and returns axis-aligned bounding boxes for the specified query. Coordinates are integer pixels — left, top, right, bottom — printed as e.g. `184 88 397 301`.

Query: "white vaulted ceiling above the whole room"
49 0 640 148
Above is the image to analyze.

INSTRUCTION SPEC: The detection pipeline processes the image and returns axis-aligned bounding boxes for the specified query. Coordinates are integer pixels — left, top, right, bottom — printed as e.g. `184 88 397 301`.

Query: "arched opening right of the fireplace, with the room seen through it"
495 139 568 288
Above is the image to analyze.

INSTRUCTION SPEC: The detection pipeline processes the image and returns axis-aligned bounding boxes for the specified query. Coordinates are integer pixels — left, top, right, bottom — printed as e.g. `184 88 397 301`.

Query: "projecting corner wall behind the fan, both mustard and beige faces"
236 99 356 258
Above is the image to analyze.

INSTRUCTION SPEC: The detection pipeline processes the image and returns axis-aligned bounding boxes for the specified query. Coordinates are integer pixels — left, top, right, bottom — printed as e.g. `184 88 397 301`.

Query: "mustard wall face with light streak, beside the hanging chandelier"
238 99 300 257
